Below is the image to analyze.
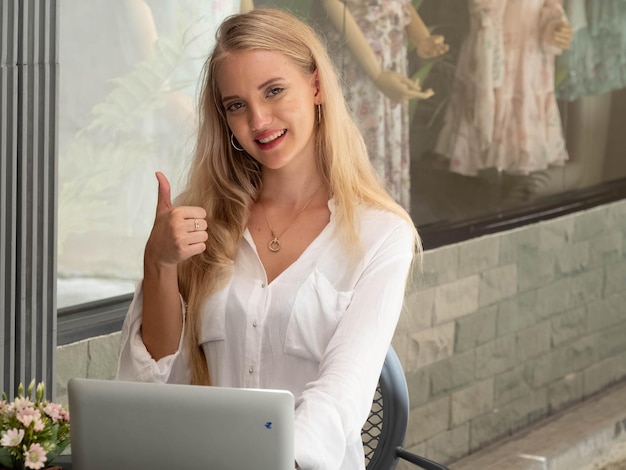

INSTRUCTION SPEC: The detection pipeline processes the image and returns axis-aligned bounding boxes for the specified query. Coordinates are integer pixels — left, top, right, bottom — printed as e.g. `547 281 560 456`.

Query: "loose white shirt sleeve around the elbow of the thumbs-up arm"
116 283 191 383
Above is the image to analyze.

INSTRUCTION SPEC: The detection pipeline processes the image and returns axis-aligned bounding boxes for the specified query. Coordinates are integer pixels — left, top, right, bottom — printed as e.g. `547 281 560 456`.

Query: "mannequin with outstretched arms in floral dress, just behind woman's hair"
312 0 448 209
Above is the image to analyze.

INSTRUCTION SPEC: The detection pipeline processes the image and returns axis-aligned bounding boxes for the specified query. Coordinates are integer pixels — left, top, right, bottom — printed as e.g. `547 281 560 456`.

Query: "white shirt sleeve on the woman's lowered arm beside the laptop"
294 221 414 470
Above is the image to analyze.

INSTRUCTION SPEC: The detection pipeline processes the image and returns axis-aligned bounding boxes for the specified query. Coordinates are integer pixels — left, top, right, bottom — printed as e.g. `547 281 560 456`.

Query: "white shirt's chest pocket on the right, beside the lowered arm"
284 270 353 362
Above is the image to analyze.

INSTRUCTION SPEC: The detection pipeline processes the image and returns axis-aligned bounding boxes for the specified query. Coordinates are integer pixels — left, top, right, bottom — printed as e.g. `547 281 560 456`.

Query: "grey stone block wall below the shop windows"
56 197 626 469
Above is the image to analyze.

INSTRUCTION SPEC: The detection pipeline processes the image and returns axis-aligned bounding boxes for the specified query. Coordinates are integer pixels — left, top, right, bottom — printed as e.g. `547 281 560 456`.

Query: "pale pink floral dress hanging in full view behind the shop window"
435 0 568 176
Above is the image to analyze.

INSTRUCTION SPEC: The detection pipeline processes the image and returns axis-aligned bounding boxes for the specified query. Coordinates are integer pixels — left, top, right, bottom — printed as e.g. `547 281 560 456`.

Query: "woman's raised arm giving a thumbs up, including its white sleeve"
116 173 208 383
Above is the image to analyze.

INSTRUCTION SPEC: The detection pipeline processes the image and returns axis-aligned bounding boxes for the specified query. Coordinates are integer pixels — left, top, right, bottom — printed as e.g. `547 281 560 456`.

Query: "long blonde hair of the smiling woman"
178 8 421 384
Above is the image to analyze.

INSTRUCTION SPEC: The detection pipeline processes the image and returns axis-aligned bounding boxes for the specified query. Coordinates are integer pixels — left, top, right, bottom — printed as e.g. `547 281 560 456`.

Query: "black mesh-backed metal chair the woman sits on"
361 347 449 470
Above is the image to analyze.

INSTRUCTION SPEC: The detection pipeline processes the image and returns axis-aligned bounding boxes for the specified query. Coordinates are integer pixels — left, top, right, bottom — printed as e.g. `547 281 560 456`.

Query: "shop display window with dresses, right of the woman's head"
300 0 626 227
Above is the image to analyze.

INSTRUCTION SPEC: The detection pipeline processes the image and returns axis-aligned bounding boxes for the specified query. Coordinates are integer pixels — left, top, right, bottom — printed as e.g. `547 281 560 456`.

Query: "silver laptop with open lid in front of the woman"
68 378 295 470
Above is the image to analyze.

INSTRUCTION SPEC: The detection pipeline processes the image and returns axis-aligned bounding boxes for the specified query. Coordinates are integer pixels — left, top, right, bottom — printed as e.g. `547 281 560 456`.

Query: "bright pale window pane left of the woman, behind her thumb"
58 0 241 307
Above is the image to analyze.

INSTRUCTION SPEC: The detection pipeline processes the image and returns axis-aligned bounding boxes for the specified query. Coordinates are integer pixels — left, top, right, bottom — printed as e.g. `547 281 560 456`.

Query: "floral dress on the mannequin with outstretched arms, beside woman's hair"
312 0 411 210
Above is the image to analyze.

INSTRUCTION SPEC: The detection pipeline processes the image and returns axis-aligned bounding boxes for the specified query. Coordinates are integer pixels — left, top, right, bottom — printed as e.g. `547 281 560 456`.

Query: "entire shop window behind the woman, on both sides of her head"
58 0 626 307
